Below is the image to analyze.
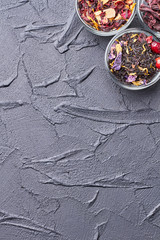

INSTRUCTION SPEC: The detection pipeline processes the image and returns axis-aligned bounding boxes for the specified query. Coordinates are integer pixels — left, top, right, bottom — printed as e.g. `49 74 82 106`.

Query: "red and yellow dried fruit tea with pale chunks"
78 0 135 32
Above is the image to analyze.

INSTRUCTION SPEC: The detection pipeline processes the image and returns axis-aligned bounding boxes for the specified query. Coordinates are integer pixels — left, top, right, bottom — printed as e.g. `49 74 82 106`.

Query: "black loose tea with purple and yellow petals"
108 33 159 86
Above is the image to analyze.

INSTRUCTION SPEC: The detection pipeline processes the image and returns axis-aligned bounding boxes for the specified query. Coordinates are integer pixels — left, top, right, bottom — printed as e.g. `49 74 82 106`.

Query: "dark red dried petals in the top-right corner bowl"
140 0 160 32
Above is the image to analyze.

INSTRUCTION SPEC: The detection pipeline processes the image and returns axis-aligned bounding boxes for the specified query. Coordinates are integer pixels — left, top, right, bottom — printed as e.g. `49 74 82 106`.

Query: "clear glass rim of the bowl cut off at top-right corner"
136 0 160 38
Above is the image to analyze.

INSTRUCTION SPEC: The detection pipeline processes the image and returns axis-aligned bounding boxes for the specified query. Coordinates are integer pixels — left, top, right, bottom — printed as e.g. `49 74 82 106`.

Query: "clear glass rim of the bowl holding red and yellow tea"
76 0 136 37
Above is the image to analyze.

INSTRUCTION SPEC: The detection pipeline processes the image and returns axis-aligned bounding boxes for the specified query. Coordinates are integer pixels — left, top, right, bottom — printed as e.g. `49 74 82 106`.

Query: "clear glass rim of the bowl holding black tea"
105 28 160 90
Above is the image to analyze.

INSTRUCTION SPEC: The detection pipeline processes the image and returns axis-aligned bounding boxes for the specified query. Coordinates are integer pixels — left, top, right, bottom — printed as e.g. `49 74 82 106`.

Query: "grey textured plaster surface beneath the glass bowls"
0 0 160 240
